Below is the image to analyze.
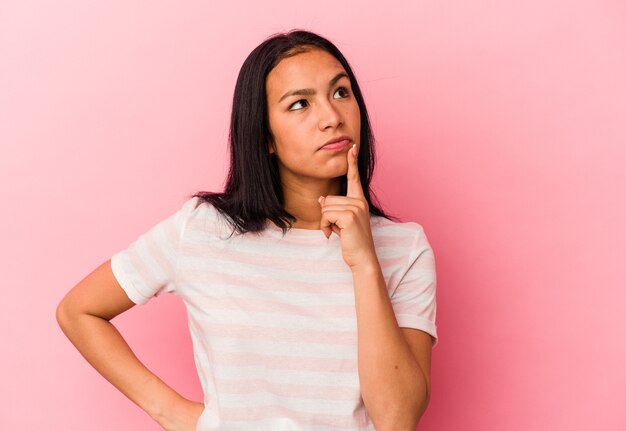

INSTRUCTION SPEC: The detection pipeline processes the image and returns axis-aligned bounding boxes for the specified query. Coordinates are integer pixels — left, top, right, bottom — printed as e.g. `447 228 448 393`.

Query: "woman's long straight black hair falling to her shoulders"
193 29 397 235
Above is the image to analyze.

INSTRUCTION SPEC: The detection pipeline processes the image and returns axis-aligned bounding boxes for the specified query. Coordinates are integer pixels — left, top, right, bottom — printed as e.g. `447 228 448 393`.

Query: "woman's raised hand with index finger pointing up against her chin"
319 146 378 270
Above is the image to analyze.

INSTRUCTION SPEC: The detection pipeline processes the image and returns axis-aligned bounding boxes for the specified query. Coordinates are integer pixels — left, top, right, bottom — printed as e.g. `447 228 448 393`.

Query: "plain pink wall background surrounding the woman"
0 0 626 431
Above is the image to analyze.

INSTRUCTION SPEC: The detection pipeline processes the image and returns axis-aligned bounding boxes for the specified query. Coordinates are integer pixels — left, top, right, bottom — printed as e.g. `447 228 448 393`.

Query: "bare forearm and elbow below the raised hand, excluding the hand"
352 266 432 431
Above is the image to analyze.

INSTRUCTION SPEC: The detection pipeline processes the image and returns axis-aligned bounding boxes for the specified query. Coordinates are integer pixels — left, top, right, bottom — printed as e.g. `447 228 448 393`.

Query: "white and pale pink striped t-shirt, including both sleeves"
111 197 437 431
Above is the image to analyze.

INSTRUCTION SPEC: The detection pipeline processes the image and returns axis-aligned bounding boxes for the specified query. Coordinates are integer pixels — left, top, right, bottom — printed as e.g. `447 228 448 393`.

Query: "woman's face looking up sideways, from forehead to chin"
266 49 361 181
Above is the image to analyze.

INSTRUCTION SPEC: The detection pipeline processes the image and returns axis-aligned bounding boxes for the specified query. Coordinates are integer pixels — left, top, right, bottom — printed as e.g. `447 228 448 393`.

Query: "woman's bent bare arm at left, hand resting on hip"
56 260 204 431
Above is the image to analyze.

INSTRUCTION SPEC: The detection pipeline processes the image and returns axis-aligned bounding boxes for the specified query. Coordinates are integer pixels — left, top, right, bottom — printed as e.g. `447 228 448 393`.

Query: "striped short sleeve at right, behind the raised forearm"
390 223 438 347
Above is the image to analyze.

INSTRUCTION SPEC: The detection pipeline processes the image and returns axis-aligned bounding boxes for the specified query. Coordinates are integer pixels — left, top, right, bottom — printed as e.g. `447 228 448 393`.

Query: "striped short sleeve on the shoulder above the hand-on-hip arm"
111 197 199 304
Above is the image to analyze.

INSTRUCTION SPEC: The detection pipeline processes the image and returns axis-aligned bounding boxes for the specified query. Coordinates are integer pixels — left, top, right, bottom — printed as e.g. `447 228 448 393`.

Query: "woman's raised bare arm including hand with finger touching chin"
320 148 432 431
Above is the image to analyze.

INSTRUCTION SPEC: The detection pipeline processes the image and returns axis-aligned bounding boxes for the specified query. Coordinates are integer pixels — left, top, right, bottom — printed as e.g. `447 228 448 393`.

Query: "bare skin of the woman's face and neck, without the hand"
266 49 361 229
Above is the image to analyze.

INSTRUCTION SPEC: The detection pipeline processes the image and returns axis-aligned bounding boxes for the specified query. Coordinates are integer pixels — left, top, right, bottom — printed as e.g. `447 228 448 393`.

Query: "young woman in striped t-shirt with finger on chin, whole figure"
57 31 437 431
